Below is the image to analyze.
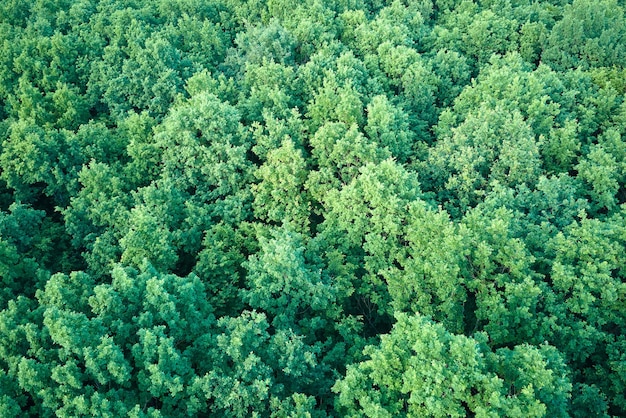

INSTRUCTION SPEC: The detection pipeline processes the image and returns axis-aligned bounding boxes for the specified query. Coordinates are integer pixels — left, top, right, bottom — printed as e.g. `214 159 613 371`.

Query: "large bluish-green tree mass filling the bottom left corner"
0 266 219 416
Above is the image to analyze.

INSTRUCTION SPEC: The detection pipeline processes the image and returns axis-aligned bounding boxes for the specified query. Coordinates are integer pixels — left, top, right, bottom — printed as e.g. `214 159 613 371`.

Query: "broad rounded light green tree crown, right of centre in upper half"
423 107 541 214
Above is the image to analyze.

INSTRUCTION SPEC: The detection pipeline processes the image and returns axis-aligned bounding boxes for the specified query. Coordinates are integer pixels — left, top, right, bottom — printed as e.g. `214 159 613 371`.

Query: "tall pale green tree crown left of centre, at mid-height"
146 92 252 248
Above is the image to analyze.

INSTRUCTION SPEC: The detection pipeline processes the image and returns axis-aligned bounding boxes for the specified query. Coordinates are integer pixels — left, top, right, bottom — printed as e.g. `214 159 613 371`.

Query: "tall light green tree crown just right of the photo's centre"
315 160 420 321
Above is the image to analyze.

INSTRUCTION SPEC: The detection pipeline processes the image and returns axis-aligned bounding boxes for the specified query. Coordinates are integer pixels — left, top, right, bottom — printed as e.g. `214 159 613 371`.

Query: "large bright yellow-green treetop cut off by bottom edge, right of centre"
333 314 571 417
